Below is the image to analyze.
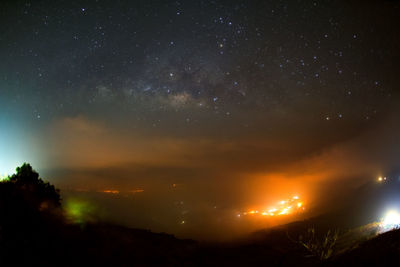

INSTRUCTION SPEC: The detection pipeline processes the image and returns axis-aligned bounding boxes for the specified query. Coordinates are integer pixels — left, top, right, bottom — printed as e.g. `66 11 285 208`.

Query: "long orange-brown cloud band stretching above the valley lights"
39 102 400 211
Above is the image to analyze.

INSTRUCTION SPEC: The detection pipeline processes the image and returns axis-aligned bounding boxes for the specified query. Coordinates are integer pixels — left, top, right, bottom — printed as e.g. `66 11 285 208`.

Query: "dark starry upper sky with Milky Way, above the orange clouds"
1 1 398 127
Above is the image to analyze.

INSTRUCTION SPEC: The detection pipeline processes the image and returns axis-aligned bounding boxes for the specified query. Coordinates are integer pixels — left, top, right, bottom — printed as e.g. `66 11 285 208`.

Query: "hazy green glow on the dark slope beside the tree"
65 198 96 224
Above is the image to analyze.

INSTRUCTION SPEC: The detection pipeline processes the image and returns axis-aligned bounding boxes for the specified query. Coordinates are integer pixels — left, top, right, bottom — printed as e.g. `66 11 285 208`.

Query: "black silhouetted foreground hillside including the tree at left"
0 165 400 266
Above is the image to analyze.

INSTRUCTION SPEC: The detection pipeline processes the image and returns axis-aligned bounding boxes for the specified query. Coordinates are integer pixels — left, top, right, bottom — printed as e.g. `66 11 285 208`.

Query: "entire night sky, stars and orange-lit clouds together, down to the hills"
0 0 400 240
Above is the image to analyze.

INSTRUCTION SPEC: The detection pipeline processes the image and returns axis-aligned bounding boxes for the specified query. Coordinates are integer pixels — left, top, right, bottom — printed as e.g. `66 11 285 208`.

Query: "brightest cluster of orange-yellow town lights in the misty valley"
237 196 304 217
